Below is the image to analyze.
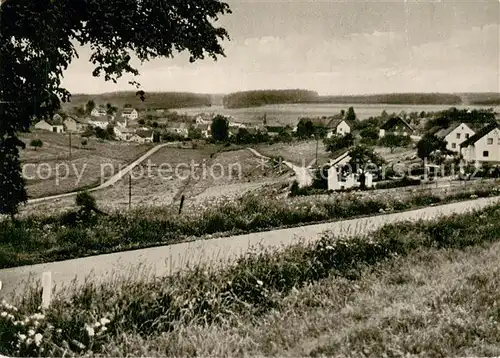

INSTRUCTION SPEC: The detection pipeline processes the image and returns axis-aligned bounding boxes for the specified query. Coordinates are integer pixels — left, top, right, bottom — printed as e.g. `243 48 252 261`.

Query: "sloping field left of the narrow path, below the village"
20 131 152 198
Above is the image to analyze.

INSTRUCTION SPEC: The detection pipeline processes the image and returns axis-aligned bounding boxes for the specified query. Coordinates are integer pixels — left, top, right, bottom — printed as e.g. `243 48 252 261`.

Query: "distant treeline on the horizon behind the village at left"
63 92 217 109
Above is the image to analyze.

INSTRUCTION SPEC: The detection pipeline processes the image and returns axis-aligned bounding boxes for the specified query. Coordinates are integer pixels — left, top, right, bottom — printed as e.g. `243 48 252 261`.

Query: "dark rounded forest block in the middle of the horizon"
223 89 318 108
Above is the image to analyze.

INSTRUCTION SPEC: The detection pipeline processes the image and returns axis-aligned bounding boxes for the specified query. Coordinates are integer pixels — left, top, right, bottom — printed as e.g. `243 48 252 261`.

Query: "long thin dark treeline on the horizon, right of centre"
316 93 462 105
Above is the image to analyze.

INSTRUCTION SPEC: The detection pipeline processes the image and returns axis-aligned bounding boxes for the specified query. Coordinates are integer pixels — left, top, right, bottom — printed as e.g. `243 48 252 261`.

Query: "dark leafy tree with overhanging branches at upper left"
0 0 230 213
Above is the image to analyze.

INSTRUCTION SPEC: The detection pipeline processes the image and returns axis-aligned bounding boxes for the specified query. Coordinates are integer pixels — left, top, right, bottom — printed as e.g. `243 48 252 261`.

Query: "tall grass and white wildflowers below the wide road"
0 205 500 356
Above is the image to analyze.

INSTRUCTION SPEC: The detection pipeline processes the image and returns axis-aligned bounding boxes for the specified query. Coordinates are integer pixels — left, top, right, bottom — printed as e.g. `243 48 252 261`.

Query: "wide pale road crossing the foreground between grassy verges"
0 197 500 296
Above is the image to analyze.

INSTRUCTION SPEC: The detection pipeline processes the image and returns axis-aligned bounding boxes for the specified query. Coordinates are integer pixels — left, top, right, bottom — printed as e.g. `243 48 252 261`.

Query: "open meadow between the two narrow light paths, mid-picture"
19 145 290 214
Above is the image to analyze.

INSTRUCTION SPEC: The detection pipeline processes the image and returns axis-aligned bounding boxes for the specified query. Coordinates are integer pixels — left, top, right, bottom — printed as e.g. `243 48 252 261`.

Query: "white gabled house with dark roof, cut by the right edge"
460 123 500 164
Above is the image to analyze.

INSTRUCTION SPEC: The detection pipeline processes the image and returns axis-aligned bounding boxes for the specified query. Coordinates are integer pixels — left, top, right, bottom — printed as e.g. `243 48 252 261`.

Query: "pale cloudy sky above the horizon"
63 0 500 95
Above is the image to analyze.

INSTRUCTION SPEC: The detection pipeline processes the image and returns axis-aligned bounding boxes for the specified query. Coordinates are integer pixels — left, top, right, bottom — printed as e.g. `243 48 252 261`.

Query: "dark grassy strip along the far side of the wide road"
0 185 498 268
